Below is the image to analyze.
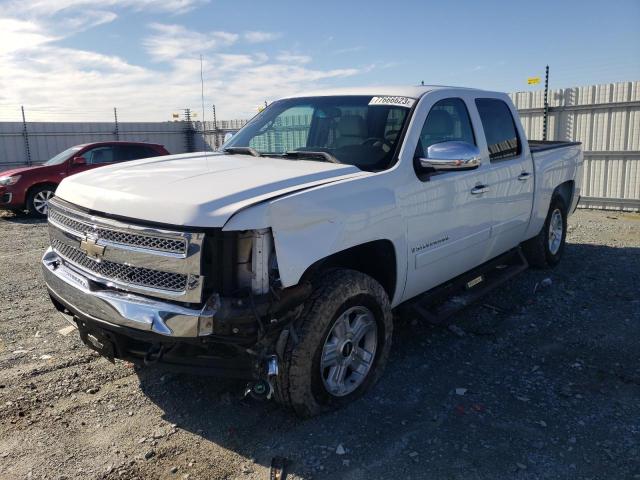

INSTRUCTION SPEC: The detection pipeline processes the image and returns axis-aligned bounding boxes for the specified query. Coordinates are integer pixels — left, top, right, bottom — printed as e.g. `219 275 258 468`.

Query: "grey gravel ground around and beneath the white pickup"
0 210 640 480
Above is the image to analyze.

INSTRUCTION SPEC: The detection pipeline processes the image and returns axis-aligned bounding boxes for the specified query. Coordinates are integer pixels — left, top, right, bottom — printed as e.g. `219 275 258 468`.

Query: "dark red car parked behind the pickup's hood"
0 142 169 217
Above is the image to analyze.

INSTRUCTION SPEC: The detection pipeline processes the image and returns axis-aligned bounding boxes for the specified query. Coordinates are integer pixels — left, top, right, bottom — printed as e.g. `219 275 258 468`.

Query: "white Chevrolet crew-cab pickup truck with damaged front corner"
42 86 583 416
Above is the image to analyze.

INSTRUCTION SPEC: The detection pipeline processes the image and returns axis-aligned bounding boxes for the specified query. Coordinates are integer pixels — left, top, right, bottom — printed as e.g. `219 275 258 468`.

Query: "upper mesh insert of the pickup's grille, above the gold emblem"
49 208 187 254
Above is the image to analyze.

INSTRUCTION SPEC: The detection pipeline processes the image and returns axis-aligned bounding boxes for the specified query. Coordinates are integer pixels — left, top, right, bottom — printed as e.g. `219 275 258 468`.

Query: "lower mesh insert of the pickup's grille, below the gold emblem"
52 239 189 292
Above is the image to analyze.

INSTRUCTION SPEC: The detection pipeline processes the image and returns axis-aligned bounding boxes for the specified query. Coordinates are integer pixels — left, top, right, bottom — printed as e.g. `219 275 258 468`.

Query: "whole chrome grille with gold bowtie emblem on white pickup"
49 197 205 303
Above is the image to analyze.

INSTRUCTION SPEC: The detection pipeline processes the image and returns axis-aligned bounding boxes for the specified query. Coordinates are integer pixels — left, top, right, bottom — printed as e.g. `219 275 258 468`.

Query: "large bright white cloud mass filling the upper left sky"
0 5 368 122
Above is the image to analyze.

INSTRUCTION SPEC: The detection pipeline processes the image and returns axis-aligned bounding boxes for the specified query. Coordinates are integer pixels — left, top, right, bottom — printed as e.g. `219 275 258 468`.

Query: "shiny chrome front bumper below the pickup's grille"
42 248 219 338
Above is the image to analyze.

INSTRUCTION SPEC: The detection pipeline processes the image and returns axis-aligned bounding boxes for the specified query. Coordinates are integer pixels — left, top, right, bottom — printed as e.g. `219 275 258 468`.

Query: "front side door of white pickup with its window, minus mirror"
405 98 492 299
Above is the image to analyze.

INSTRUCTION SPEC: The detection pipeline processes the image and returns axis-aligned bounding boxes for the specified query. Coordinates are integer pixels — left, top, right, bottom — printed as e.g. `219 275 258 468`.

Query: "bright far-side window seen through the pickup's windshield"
249 105 313 152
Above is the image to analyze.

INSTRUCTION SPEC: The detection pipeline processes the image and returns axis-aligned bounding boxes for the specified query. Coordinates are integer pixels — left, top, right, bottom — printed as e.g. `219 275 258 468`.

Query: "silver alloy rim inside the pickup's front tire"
320 306 378 397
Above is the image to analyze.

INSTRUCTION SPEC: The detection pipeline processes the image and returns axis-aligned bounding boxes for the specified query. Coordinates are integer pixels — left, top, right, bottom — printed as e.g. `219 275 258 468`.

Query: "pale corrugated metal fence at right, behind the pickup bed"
511 81 640 210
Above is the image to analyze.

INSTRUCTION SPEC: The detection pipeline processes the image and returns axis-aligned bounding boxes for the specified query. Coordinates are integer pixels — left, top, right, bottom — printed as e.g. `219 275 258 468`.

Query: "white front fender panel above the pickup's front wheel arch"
224 174 407 304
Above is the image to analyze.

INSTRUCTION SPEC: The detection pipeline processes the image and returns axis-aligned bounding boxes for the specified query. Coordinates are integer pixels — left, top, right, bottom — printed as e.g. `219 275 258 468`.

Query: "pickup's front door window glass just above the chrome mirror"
415 98 476 157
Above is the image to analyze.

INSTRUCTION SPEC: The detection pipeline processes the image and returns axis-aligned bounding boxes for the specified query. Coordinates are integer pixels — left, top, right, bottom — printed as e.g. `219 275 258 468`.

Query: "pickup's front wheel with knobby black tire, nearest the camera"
275 269 393 417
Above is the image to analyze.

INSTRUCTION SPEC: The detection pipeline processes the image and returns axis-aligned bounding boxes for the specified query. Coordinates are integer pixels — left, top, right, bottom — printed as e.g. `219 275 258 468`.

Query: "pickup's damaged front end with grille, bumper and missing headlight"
42 200 311 396
